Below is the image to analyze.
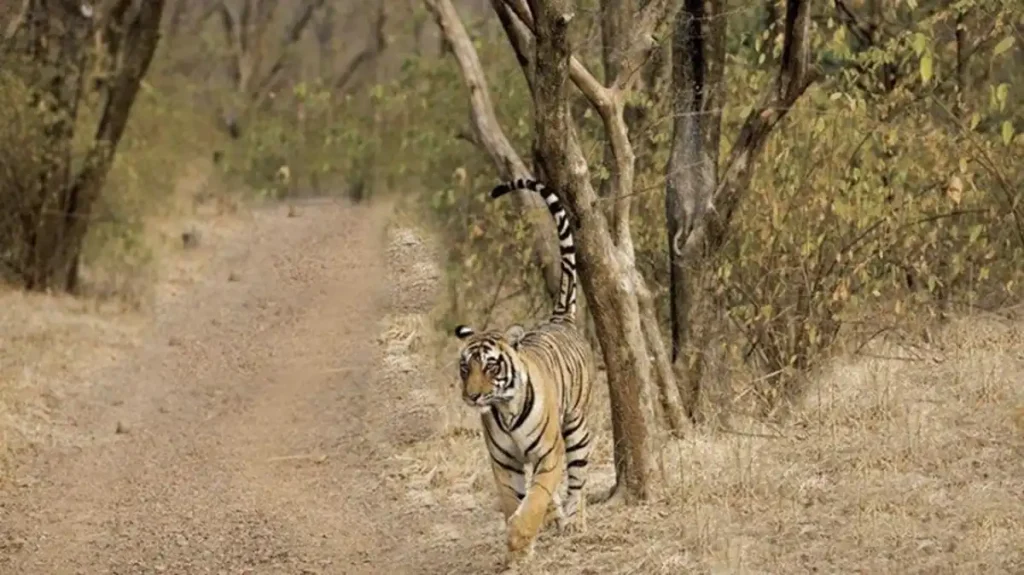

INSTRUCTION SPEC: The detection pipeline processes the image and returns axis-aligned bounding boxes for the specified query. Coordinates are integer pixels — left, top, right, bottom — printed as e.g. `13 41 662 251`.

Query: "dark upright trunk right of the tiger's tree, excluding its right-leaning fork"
665 0 726 422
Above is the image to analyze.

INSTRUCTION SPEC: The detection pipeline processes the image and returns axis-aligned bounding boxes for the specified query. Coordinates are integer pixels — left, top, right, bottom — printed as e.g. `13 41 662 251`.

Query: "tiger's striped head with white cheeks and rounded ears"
455 325 526 412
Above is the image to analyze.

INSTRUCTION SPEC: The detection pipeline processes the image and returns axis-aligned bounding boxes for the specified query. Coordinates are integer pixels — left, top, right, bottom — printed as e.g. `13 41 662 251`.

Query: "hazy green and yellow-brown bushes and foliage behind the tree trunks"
0 0 1024 564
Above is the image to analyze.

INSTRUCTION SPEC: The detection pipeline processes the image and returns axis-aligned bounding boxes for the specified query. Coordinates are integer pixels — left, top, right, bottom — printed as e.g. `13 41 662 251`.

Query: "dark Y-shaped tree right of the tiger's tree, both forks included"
666 0 816 413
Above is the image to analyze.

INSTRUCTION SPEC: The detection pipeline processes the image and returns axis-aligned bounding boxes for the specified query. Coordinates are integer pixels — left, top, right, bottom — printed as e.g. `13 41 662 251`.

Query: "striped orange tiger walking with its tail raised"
455 178 597 562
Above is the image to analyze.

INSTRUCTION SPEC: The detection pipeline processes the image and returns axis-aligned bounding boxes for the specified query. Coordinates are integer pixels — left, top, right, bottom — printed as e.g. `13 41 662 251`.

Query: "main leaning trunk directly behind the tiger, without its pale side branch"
529 0 651 501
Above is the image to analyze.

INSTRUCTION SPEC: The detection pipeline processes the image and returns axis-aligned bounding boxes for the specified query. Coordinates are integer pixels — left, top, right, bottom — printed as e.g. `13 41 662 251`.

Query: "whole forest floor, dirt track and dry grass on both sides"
0 186 1024 575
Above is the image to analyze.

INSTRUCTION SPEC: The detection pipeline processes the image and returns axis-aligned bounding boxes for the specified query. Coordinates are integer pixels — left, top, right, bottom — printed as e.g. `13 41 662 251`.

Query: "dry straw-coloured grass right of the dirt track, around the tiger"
382 225 1024 574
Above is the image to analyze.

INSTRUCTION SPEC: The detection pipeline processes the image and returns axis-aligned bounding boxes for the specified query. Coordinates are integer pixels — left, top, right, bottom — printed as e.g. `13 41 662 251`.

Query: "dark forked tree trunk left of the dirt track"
12 0 164 291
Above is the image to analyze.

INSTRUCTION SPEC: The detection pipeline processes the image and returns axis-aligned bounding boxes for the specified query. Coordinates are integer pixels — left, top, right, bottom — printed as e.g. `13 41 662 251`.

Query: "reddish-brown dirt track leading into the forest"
0 203 489 575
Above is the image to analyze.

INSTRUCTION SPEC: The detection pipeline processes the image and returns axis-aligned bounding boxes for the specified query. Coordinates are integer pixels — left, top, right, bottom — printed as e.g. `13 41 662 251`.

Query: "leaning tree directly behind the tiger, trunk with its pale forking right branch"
517 0 670 501
